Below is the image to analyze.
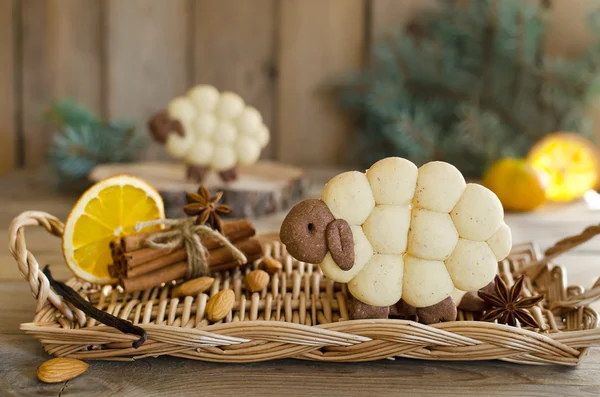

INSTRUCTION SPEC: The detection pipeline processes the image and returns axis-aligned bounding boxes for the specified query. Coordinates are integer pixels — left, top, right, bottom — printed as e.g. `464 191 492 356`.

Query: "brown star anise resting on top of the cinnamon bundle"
183 185 231 233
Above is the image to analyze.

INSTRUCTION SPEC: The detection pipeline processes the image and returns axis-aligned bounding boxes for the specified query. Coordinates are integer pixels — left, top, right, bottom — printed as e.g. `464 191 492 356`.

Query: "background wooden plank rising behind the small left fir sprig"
21 0 102 166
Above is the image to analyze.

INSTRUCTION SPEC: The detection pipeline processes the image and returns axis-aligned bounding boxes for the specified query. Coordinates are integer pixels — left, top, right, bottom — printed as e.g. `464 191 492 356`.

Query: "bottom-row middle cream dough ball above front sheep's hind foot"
402 255 454 307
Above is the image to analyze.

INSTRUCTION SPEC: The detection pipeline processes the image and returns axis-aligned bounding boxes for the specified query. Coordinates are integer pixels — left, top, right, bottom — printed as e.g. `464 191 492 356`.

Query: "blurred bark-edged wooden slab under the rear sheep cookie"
89 160 309 218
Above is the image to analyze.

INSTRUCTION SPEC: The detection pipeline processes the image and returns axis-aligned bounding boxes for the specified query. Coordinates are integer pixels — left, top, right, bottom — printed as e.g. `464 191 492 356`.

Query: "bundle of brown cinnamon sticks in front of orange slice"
109 219 262 292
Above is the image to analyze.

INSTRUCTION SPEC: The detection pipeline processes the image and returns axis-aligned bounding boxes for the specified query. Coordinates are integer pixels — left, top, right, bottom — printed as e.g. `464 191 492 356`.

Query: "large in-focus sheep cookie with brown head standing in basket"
280 157 512 323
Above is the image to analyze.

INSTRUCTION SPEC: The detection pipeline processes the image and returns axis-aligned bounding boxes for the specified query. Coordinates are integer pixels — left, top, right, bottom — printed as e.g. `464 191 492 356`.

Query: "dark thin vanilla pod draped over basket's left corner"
44 265 148 349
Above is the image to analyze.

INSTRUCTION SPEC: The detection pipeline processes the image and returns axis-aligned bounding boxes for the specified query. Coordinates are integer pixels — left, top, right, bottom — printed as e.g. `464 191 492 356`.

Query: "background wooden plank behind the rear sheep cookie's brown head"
103 0 191 159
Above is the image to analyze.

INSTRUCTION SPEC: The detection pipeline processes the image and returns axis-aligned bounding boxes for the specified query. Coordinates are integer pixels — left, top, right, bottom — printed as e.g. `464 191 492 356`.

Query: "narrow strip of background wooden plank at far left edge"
0 0 18 174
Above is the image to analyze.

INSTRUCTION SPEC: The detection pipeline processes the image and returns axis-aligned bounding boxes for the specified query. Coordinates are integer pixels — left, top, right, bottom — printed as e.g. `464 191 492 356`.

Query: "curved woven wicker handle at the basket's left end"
8 211 73 320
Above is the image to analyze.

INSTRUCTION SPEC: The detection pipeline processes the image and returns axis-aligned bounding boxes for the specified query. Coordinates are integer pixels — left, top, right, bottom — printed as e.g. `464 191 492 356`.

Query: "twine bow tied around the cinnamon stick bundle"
135 218 247 278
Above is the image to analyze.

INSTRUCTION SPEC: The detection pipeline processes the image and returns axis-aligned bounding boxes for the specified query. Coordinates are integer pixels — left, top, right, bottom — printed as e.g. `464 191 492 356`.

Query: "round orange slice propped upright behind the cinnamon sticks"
62 175 164 284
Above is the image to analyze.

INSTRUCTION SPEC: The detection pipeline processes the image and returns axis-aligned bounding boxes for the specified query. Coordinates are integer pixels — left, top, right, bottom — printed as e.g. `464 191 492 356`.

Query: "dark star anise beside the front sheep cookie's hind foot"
479 276 544 328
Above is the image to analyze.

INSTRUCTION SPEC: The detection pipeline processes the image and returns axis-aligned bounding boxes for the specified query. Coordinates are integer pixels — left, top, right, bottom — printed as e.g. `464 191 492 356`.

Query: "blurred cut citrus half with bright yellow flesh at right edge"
527 132 600 201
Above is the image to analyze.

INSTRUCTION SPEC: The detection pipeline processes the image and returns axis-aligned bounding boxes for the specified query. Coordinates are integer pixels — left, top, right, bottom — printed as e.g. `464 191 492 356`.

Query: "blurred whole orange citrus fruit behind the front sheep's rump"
482 159 546 211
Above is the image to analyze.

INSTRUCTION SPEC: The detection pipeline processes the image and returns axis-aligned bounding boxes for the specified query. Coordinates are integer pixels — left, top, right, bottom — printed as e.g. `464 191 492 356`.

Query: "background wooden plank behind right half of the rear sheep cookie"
192 0 278 158
